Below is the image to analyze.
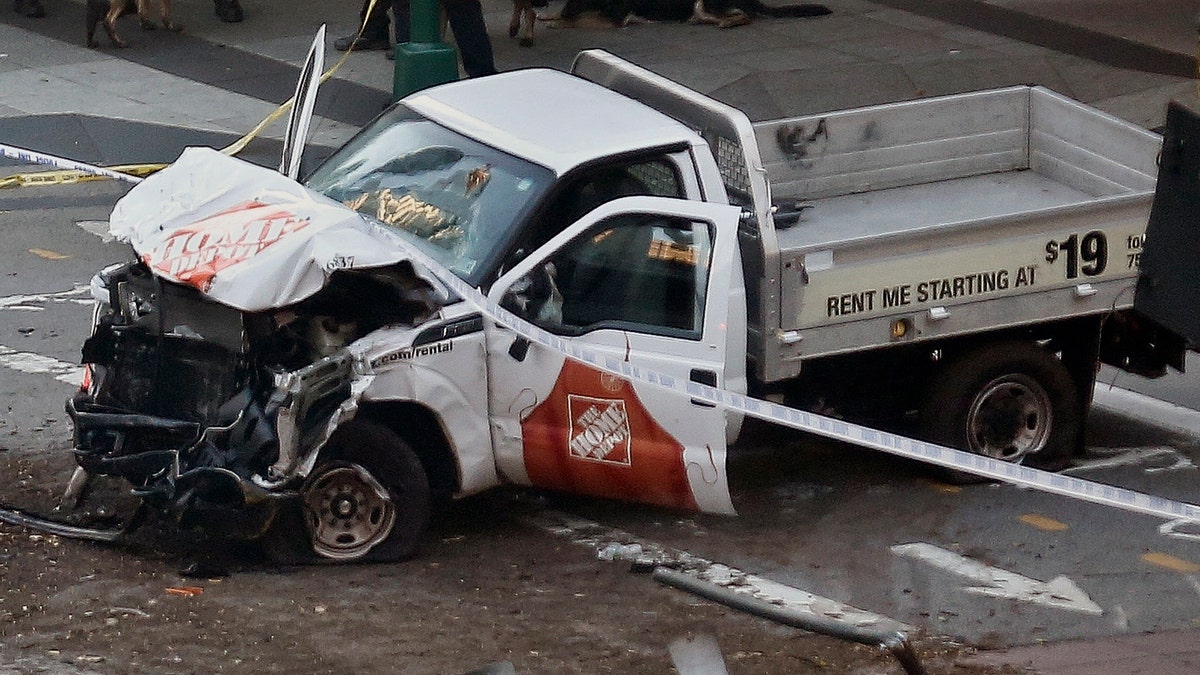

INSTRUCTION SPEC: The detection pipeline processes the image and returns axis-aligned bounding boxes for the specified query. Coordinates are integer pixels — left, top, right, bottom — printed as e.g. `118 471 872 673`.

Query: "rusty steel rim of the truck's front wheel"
302 464 396 560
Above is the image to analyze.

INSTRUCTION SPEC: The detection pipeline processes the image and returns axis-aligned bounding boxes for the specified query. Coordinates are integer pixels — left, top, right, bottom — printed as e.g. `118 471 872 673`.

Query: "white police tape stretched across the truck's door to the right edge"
367 218 1200 522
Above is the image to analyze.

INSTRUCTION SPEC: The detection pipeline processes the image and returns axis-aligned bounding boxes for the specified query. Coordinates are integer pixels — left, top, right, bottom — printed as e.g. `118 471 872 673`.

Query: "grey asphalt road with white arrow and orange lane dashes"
0 171 1200 647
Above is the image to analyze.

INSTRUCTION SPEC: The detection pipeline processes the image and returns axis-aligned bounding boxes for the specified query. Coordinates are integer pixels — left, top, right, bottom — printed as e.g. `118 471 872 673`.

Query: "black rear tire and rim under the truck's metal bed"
920 341 1082 483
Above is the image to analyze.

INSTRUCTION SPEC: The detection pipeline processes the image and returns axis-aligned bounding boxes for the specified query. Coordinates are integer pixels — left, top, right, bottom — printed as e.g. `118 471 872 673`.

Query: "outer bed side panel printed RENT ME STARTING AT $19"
781 195 1151 366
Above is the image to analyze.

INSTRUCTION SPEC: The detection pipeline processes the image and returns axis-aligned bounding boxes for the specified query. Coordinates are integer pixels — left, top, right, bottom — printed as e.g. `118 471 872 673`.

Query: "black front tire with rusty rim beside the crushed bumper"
266 422 432 562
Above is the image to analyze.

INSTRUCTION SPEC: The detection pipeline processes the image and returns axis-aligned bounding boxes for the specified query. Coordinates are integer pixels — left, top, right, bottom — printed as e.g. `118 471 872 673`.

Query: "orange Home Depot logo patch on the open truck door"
521 359 697 510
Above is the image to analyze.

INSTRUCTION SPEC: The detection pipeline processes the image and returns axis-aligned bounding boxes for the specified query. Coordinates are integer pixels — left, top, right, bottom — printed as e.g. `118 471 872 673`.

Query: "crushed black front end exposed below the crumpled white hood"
67 257 436 538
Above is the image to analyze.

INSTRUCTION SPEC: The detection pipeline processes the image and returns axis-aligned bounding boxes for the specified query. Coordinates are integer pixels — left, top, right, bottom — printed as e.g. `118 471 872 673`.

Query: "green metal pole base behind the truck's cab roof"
391 0 458 101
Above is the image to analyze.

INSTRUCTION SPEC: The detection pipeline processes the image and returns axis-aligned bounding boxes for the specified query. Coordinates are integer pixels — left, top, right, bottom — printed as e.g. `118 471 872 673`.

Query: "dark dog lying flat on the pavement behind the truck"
554 0 830 28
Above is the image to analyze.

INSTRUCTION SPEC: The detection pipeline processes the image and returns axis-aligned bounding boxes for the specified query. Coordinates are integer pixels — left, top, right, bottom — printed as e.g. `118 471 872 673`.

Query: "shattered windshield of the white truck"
305 106 553 285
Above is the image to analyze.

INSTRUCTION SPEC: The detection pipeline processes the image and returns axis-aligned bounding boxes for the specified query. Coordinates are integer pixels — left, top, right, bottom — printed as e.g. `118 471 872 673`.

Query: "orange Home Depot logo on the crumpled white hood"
145 201 312 285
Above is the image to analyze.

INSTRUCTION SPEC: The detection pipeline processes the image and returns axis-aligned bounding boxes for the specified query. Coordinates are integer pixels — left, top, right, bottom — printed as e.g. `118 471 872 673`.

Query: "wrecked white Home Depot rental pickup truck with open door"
68 50 1184 560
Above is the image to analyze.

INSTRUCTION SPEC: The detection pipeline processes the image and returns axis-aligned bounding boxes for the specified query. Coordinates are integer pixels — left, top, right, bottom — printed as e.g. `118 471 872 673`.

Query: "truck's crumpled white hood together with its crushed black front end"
67 149 454 548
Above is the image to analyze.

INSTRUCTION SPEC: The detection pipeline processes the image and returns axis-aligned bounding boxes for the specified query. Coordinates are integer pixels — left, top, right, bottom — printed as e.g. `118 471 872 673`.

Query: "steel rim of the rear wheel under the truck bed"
967 374 1054 462
